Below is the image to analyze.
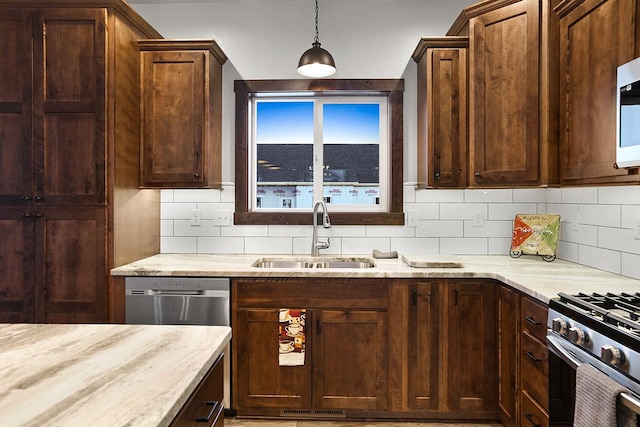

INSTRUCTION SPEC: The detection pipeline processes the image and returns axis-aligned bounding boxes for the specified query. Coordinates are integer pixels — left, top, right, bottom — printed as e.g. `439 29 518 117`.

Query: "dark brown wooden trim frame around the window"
234 79 404 225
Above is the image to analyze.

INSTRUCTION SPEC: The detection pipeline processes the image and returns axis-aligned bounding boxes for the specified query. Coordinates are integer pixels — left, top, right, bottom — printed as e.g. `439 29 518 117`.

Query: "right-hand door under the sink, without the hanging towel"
313 310 388 411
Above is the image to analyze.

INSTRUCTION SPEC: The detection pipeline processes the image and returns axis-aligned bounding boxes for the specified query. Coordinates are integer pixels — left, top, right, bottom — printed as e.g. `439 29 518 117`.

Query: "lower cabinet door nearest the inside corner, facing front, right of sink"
444 281 497 415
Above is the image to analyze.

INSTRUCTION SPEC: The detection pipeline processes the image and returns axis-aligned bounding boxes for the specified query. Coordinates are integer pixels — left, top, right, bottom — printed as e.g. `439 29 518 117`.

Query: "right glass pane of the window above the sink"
322 103 380 205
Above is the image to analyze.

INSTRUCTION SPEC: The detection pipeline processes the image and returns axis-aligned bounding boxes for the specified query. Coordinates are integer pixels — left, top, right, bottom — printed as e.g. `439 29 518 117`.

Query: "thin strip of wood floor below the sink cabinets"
224 418 502 427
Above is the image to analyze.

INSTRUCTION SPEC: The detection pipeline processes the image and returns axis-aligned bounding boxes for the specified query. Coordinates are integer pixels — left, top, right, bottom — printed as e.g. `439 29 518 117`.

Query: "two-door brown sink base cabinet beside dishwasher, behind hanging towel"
232 278 389 416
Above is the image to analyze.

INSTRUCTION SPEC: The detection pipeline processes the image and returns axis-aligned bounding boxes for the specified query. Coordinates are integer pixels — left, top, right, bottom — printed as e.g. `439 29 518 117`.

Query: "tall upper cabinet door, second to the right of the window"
469 0 540 186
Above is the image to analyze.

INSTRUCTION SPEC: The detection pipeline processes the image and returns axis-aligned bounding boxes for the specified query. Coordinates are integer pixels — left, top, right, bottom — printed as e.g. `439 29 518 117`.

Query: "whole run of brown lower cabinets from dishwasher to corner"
232 278 498 420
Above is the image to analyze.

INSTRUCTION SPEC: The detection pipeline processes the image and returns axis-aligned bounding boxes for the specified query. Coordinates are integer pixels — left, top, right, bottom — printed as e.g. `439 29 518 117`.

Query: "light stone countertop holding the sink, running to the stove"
111 254 640 303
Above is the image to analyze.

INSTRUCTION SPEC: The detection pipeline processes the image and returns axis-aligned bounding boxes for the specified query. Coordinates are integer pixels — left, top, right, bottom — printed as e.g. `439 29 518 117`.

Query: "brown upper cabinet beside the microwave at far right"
556 0 640 185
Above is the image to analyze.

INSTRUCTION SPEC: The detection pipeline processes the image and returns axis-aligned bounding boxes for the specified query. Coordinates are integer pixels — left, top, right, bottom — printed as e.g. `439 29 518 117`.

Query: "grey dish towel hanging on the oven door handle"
573 363 637 427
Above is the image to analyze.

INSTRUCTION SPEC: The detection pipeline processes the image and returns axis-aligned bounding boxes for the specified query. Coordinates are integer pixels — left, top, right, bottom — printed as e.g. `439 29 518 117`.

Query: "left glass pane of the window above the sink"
255 101 313 209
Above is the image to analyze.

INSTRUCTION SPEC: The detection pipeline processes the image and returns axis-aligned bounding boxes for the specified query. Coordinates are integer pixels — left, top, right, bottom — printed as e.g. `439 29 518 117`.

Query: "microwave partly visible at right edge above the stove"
616 58 640 168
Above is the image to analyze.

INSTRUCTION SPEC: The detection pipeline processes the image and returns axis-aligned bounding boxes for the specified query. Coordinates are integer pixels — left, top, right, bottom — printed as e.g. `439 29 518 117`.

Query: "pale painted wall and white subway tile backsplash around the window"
130 0 640 278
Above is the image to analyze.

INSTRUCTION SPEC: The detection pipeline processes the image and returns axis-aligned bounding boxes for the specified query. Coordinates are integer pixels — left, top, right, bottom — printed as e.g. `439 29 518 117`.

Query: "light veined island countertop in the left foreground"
0 324 231 427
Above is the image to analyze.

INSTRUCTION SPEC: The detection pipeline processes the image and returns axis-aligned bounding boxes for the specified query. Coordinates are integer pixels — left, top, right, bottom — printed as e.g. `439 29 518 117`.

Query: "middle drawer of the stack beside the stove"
520 332 549 409
